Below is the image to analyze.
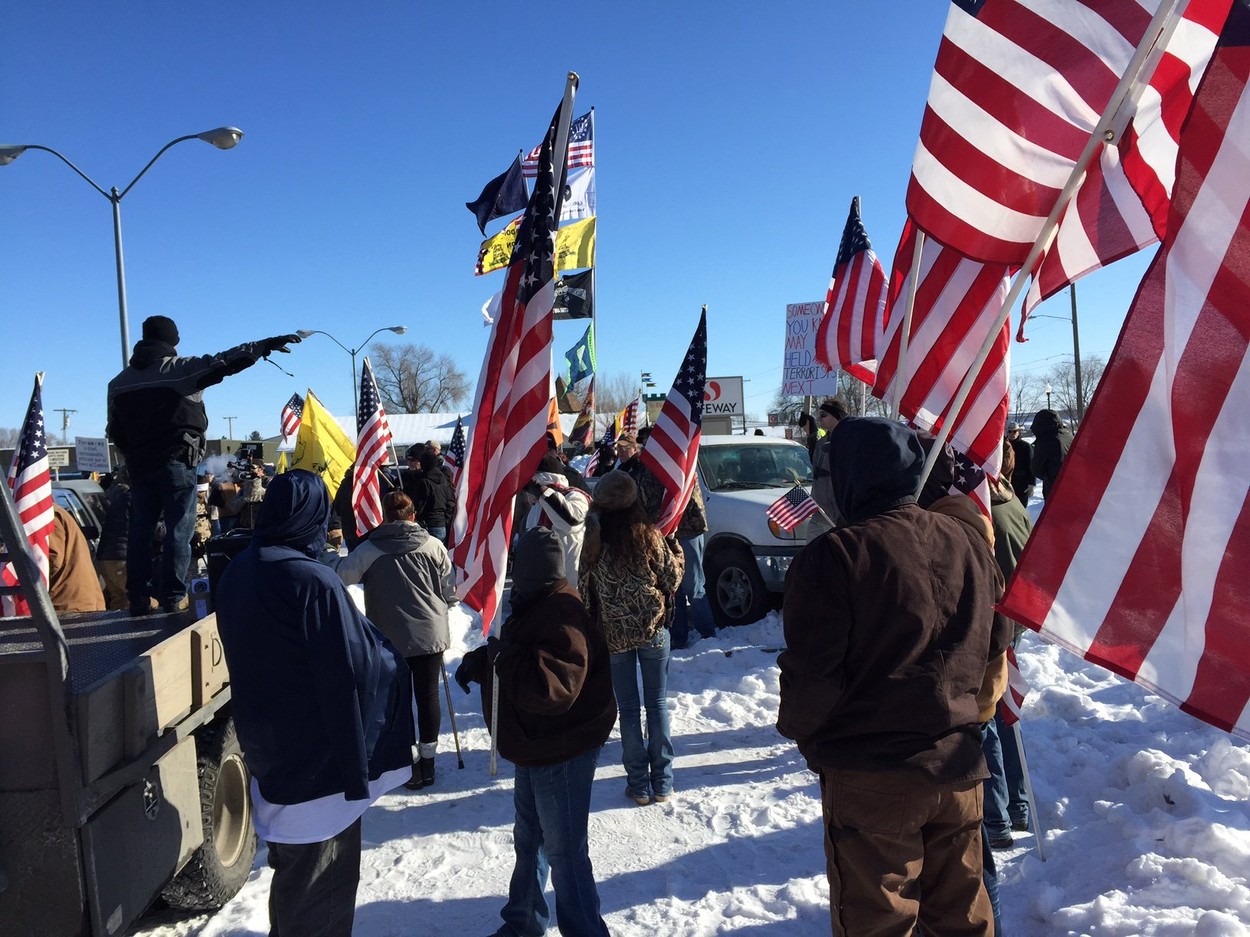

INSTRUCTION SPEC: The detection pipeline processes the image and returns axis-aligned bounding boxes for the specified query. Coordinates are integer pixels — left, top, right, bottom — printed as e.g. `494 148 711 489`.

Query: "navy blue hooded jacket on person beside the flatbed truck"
216 470 414 805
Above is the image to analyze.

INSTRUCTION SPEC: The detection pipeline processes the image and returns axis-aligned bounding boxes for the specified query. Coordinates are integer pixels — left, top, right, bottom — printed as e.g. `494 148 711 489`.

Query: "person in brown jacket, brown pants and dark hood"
778 417 1010 937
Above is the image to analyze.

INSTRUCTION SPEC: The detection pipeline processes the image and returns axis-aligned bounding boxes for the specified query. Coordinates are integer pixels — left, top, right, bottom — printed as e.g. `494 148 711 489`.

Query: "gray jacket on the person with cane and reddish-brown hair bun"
334 521 456 657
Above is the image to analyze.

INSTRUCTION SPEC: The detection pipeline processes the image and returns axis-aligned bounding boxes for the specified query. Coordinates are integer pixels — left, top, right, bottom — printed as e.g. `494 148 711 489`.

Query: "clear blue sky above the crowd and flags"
0 0 1149 447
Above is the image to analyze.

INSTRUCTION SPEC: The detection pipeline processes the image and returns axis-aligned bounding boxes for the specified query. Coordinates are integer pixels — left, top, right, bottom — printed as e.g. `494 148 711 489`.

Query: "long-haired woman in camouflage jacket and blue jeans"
580 470 684 806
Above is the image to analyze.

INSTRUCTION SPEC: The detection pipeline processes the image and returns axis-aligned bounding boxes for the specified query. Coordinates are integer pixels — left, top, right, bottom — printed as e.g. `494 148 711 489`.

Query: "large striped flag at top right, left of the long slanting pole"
906 0 1180 264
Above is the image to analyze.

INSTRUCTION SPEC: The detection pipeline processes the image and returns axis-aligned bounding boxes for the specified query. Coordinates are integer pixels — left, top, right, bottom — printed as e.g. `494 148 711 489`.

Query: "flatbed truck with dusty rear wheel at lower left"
0 483 256 937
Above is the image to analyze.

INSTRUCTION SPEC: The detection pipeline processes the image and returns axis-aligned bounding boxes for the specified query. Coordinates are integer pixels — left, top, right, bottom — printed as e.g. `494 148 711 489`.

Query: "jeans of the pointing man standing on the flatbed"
126 460 195 605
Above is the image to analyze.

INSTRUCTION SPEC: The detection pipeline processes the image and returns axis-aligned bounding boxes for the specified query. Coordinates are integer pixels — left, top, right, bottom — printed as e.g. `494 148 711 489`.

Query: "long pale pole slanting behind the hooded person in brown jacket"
916 0 1189 492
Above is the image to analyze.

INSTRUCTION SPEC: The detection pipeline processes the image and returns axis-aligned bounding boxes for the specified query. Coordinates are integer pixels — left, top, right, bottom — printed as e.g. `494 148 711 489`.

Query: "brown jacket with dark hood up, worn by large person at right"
778 417 999 783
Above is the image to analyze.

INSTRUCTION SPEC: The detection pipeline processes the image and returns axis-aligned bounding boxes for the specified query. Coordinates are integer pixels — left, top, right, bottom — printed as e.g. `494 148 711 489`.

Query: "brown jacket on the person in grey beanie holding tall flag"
481 581 616 767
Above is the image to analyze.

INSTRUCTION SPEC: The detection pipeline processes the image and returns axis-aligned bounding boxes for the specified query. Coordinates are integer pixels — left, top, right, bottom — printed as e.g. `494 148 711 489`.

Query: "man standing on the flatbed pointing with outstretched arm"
108 316 300 615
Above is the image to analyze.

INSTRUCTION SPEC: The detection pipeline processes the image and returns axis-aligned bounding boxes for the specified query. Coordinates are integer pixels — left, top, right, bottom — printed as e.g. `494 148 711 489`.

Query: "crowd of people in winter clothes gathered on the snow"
14 316 1071 937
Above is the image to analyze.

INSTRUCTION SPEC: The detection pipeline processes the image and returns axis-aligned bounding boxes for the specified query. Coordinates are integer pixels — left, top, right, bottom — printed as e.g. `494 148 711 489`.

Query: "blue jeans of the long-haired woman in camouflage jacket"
611 628 673 796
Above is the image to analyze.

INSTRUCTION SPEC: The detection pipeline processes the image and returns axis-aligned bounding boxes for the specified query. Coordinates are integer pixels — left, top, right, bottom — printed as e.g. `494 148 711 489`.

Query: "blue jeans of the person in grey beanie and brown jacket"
496 748 608 937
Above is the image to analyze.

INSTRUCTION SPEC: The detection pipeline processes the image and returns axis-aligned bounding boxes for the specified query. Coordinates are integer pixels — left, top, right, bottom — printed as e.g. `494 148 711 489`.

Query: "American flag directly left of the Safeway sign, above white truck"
639 309 708 536
